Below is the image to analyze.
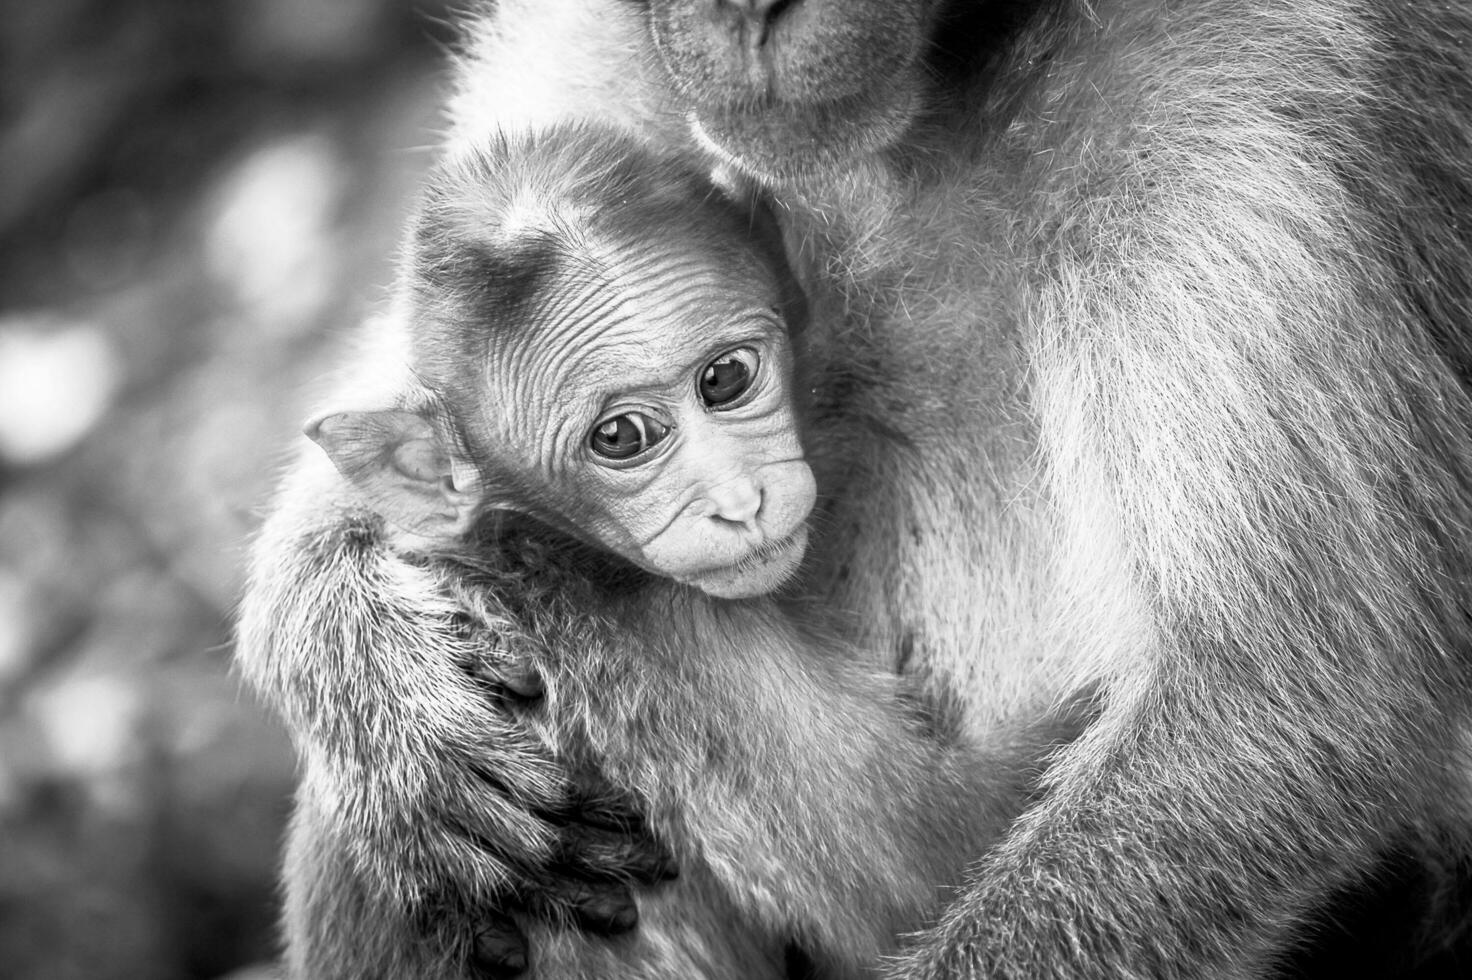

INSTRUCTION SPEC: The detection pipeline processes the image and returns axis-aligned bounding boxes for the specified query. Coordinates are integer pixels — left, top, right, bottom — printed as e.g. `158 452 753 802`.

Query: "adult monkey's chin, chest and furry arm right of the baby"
461 0 1472 977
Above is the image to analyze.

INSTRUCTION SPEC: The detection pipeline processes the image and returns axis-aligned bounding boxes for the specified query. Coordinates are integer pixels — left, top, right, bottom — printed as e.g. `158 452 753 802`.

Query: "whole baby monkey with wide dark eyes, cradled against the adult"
299 129 1036 980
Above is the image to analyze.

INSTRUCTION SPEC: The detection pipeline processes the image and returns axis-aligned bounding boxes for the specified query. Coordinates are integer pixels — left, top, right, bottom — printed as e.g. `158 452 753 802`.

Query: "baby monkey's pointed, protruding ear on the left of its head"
302 409 481 550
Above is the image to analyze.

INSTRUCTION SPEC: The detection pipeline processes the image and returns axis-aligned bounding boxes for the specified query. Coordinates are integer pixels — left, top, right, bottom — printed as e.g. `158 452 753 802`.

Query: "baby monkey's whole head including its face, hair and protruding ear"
308 128 814 597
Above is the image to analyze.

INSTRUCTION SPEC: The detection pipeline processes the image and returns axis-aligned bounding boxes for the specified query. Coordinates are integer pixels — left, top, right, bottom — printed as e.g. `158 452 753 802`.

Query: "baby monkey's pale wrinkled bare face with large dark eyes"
489 237 814 597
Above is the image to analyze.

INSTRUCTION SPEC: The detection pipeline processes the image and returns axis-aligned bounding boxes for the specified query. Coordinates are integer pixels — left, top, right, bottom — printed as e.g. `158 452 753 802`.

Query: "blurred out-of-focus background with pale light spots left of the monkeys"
0 0 453 980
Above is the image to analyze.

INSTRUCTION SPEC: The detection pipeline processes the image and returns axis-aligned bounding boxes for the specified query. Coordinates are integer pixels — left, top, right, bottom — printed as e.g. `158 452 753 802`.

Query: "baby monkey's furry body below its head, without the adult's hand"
447 531 1054 980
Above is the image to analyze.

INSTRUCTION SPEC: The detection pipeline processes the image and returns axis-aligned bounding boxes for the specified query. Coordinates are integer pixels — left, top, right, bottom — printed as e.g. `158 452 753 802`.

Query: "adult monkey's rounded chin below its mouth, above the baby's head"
689 84 919 184
